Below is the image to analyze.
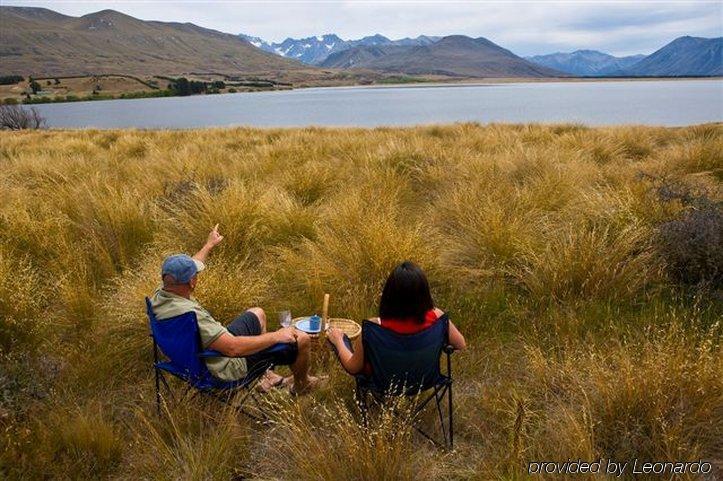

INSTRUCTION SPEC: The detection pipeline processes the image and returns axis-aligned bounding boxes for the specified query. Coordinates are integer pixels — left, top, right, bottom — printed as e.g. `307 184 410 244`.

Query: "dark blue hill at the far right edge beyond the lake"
613 36 723 76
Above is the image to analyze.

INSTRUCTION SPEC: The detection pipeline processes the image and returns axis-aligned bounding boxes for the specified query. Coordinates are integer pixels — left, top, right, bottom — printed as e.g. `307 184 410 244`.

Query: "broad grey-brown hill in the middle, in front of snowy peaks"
321 35 565 77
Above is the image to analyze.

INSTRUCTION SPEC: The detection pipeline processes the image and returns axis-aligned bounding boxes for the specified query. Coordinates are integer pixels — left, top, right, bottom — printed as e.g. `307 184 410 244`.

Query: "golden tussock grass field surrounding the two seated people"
0 124 723 480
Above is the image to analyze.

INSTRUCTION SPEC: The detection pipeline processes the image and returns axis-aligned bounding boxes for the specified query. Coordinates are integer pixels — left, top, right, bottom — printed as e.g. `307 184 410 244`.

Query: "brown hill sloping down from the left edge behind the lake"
0 6 309 76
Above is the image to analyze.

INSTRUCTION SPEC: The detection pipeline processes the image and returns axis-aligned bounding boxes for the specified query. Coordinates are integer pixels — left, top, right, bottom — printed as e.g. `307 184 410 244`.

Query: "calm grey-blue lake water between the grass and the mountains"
31 79 723 128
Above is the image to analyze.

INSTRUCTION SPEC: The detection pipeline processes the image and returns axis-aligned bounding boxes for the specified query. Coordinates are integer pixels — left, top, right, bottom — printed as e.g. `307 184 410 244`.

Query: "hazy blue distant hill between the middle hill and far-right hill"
525 50 645 76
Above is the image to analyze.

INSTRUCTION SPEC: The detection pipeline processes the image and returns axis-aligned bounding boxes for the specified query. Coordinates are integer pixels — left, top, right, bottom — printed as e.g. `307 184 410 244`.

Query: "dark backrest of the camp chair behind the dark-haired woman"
362 314 449 395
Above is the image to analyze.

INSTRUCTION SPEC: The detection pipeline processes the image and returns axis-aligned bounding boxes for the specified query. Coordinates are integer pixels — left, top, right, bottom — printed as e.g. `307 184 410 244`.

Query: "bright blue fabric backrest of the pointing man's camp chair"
146 297 211 383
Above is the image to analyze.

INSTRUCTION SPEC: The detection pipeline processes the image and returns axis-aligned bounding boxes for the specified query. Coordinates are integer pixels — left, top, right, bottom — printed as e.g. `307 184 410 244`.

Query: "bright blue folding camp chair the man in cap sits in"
146 297 289 421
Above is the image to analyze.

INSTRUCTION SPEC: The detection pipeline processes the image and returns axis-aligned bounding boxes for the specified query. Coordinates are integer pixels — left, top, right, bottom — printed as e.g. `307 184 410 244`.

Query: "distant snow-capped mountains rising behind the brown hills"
239 33 440 65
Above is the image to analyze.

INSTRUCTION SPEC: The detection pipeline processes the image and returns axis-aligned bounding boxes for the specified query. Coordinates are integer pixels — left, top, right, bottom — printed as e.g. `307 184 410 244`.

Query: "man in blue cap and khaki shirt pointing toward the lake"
151 224 319 394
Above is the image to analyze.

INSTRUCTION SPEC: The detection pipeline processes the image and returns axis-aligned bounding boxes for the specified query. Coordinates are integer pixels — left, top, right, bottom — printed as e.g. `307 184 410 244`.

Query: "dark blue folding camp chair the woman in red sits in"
356 314 454 449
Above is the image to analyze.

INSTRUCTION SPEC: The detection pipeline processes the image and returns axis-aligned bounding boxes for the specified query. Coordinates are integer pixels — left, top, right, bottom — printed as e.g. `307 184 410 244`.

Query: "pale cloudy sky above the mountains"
5 0 723 56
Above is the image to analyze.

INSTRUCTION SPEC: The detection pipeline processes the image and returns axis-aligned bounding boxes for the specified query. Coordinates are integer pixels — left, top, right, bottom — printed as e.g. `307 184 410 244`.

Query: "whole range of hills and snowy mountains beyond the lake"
0 6 723 80
